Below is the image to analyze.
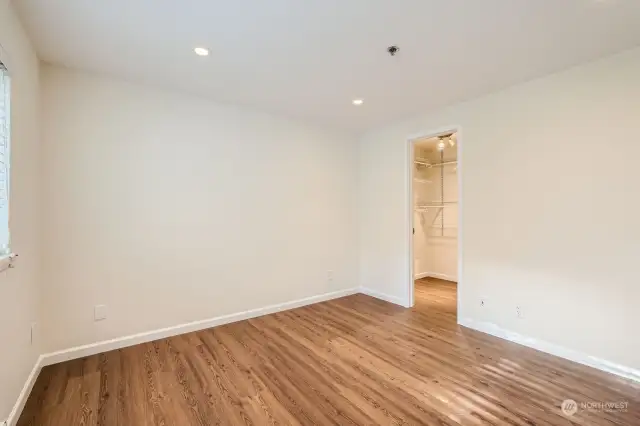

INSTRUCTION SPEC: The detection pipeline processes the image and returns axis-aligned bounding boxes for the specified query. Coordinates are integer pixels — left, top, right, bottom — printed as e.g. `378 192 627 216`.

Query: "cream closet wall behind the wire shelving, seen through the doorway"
413 146 458 281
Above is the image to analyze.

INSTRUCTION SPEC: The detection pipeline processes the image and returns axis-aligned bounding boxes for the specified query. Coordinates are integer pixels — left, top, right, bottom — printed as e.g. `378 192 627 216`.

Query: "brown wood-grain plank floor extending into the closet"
18 279 640 426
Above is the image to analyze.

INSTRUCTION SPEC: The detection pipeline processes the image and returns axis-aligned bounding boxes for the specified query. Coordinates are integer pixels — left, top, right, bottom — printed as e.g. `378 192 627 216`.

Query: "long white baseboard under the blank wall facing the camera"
42 288 359 366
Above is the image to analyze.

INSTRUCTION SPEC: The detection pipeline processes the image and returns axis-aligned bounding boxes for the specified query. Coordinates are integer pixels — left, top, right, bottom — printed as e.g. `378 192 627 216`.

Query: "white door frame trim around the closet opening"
404 126 464 312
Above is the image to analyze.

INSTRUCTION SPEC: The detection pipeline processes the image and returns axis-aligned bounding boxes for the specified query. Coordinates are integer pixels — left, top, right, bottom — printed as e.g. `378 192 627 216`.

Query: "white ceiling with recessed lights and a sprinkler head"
14 0 640 131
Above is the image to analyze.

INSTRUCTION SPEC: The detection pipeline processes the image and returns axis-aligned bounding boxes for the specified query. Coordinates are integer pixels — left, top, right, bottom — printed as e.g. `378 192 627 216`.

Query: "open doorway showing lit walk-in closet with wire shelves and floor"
411 132 459 315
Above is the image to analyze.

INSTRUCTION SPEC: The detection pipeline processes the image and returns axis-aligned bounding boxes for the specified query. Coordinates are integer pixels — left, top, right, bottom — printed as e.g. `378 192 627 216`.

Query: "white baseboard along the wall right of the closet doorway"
458 318 640 382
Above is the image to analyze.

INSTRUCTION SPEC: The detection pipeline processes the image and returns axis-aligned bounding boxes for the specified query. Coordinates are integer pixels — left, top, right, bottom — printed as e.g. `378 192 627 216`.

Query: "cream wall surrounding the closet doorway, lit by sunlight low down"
360 49 640 369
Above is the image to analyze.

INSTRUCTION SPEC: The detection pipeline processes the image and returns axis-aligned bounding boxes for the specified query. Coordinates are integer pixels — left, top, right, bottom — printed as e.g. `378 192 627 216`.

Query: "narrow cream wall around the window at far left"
0 0 41 420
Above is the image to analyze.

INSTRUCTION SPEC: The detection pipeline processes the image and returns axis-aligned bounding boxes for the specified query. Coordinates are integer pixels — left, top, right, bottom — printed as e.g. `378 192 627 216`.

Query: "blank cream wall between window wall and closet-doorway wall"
42 66 358 351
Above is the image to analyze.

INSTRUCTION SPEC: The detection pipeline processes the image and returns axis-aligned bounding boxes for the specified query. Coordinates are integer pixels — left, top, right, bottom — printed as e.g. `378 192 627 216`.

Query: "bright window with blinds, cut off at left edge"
0 62 11 256
